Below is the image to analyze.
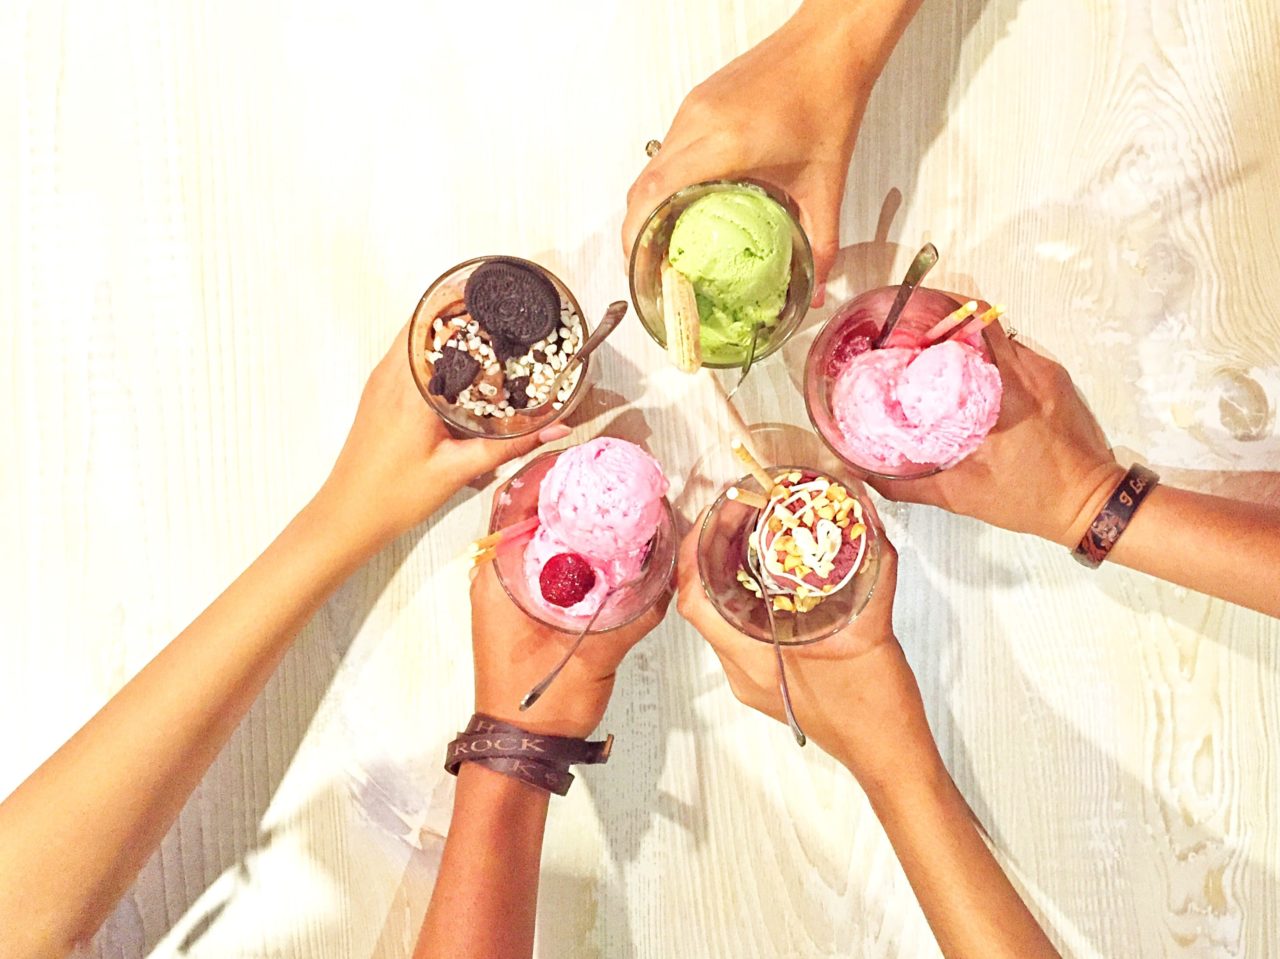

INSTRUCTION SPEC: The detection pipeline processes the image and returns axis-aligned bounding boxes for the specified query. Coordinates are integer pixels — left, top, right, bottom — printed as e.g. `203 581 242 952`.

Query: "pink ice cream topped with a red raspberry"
525 437 669 616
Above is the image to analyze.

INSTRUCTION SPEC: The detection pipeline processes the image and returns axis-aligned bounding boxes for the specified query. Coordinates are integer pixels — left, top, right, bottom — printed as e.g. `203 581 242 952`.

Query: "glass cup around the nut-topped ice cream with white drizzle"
698 466 883 645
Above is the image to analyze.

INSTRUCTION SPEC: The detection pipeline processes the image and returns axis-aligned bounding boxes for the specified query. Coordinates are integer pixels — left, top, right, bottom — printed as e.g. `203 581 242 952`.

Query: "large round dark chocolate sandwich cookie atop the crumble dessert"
462 260 561 350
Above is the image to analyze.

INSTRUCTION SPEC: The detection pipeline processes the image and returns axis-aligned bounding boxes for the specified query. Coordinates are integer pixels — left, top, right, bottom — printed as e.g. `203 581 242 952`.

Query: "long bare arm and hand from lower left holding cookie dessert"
0 325 558 959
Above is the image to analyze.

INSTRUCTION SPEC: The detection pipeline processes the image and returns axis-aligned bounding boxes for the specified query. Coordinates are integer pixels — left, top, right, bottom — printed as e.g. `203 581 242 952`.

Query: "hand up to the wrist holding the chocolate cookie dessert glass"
317 324 570 548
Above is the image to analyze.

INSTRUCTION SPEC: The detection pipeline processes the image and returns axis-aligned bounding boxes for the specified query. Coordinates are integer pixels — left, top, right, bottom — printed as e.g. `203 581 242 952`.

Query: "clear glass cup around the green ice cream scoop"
628 179 814 370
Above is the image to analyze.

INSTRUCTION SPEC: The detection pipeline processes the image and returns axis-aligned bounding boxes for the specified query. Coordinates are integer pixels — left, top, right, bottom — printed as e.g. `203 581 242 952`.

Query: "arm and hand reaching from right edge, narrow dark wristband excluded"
870 325 1280 616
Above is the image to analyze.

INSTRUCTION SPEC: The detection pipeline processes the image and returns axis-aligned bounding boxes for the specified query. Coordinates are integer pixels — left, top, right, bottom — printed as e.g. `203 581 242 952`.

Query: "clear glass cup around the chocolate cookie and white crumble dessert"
408 255 591 439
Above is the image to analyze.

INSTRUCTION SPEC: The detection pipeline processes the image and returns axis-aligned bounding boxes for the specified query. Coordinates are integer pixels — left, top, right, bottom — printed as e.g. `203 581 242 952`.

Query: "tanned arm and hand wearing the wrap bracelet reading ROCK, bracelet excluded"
413 563 667 959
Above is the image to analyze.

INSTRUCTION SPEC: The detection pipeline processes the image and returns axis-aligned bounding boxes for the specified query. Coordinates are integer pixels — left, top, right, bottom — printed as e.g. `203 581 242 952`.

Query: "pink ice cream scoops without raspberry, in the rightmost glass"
831 339 1004 471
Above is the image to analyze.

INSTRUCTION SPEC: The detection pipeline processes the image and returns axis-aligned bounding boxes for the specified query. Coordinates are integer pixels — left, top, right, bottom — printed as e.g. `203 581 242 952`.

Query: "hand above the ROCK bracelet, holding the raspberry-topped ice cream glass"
471 563 671 739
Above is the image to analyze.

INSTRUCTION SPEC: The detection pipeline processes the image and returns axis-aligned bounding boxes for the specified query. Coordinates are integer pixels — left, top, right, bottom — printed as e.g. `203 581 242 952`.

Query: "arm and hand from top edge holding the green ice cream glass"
622 0 922 305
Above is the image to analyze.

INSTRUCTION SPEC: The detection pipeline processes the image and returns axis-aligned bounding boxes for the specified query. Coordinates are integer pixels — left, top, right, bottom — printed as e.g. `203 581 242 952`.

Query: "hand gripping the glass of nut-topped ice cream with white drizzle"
677 522 941 794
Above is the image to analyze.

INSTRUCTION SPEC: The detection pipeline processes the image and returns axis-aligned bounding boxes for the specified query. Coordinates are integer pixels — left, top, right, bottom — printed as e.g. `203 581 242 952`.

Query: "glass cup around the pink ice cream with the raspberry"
489 449 678 633
